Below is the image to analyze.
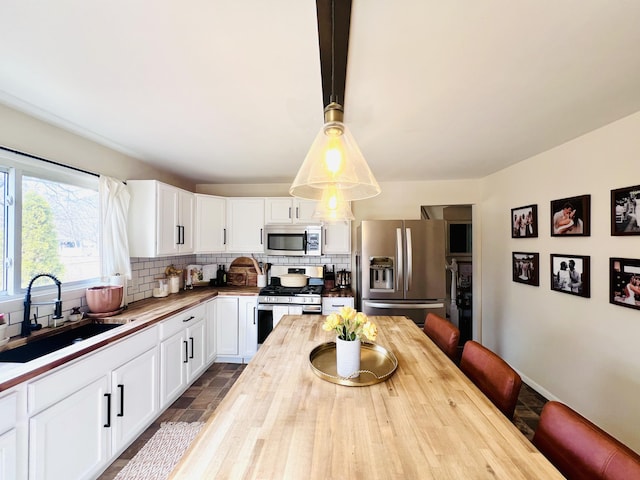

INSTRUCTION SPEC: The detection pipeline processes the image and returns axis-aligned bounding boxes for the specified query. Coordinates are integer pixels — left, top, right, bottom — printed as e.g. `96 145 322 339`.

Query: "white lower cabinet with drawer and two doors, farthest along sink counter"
160 305 206 408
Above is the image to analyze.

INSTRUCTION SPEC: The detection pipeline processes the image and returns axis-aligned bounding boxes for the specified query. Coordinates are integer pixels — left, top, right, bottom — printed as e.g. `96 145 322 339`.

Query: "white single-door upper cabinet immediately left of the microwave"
227 197 264 253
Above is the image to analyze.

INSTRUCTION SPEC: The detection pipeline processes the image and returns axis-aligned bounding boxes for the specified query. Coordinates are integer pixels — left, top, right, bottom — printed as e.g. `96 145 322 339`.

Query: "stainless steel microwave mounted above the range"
264 225 322 257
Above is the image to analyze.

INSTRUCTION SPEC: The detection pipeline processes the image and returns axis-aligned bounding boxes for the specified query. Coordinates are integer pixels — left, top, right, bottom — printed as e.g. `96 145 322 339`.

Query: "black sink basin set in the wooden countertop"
0 323 121 363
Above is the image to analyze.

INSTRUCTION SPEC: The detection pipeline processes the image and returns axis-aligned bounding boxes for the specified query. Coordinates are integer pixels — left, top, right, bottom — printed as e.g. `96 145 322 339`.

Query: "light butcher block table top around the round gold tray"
170 315 564 480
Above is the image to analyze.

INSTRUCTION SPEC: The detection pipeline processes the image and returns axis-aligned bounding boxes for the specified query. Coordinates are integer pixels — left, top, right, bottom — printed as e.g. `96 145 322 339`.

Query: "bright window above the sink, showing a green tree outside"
0 151 100 294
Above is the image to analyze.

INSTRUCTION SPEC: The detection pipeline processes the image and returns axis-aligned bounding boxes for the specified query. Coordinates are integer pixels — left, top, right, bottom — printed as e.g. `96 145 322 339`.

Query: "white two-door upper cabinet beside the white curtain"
127 180 195 257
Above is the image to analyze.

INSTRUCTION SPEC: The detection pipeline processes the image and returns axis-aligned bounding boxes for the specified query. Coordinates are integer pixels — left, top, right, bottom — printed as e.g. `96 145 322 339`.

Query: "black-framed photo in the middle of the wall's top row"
551 195 591 237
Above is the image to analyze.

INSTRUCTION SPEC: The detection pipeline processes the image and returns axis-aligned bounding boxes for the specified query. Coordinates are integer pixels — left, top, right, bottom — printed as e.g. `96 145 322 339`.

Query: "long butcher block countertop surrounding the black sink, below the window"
0 286 260 392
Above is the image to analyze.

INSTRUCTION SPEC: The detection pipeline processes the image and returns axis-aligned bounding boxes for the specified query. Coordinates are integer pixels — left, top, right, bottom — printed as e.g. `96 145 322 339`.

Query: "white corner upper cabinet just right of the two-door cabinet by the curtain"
195 193 227 253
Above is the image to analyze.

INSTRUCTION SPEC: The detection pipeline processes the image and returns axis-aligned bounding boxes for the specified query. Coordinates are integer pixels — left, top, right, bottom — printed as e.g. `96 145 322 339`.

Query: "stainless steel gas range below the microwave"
258 265 324 344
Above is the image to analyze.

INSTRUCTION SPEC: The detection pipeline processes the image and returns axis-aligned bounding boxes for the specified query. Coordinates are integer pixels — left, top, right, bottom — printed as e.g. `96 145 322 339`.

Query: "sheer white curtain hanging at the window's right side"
100 175 131 280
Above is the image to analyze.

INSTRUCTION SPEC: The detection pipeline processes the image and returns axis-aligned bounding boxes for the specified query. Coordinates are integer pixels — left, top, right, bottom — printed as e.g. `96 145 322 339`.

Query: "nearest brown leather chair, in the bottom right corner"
533 401 640 480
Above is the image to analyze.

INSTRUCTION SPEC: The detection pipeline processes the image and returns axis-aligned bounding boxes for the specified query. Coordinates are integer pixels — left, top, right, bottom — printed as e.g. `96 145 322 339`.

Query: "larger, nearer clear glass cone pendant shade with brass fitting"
289 103 380 202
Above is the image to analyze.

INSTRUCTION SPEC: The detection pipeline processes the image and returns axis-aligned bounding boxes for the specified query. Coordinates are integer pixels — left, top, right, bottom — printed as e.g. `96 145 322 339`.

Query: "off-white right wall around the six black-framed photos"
482 109 640 452
